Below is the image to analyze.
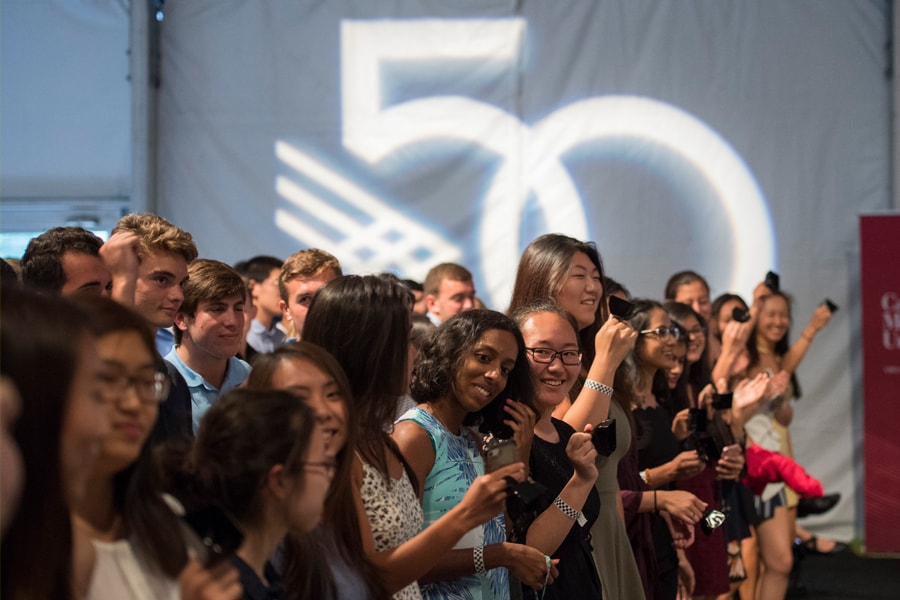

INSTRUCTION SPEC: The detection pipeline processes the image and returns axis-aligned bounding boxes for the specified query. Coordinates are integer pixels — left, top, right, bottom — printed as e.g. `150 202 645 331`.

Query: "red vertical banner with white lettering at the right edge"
860 215 900 552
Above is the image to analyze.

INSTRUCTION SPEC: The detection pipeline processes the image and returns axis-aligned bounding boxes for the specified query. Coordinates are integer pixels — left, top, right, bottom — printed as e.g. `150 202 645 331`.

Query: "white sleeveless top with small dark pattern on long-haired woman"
356 453 422 600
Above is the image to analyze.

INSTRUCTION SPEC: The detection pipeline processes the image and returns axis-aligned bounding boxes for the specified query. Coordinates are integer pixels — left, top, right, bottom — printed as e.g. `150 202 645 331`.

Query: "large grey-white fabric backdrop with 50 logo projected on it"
159 0 891 537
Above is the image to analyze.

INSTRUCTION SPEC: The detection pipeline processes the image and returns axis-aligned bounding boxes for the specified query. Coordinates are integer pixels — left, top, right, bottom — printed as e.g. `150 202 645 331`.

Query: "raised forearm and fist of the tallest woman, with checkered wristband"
562 318 637 431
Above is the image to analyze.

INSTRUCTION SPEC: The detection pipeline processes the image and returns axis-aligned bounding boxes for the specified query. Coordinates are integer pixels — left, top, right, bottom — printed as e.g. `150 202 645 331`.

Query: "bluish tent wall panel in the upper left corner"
0 0 133 239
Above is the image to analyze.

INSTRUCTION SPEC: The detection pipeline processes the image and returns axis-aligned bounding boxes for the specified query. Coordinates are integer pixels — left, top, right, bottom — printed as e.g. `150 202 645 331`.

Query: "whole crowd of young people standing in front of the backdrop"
0 214 838 600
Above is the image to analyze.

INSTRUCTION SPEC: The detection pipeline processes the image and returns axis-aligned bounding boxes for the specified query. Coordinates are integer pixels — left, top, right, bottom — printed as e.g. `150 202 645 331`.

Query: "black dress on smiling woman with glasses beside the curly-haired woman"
507 419 602 600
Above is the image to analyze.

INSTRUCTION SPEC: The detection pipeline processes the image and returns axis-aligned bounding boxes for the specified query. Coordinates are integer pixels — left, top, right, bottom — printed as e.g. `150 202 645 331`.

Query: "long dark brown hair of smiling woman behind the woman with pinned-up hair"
247 340 390 600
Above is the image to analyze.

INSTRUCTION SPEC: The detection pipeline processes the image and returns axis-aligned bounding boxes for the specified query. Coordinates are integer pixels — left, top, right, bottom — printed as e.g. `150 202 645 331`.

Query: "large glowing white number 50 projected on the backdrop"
341 18 774 306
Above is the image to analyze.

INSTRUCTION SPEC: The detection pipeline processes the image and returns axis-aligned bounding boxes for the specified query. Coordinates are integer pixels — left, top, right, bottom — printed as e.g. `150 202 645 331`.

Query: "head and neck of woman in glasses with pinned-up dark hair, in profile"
169 388 335 600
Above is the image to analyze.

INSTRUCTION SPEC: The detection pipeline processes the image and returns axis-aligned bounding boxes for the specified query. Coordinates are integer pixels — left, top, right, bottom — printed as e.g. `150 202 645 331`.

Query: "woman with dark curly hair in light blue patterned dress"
394 310 552 599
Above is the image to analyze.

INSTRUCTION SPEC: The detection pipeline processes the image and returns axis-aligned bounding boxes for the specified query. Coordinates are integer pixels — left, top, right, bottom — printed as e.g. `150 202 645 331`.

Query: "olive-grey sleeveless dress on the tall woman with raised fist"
591 400 645 600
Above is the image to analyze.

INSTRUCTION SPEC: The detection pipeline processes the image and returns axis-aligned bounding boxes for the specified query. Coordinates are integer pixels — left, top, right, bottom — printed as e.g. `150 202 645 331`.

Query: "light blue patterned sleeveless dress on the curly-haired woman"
400 408 509 600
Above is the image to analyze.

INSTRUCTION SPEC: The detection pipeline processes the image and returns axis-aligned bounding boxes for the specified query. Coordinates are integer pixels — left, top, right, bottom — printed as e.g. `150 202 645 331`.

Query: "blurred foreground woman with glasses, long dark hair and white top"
72 297 240 600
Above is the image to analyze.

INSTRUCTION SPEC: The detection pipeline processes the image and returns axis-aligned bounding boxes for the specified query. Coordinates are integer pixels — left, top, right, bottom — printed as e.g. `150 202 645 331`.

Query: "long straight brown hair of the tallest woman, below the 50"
507 233 609 366
